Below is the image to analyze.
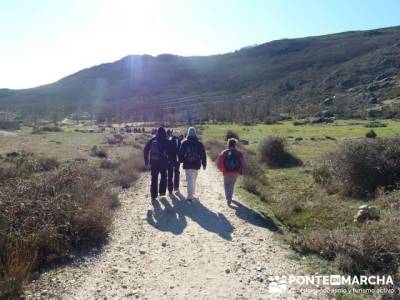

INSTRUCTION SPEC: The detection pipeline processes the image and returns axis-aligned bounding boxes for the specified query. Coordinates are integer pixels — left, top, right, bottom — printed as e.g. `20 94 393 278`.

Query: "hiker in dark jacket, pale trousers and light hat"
179 127 207 202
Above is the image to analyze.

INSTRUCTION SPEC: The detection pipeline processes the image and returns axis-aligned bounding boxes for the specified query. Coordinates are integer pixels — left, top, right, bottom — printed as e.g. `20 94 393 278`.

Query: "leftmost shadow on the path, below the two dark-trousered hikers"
147 198 187 235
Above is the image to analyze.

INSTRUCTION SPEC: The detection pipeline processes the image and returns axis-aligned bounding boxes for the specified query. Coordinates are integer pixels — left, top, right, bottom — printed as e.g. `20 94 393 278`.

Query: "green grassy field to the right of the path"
201 120 400 299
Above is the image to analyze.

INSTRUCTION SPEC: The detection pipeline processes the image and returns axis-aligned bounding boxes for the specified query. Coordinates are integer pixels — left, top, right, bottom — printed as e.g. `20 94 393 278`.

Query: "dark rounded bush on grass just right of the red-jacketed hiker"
259 137 302 167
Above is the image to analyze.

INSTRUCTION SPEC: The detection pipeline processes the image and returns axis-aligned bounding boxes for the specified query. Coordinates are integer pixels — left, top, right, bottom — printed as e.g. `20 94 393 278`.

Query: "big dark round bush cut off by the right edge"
331 138 400 197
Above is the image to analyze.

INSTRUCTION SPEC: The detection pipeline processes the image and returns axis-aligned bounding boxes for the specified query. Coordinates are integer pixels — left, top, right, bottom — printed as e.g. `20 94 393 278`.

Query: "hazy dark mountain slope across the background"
0 27 400 119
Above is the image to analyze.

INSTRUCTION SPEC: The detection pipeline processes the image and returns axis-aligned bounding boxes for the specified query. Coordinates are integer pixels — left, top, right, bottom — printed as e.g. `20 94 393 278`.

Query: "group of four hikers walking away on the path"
144 127 246 206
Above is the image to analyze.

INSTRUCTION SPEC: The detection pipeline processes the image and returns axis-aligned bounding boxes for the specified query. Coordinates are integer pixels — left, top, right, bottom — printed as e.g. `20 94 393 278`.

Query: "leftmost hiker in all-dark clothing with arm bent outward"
143 127 168 200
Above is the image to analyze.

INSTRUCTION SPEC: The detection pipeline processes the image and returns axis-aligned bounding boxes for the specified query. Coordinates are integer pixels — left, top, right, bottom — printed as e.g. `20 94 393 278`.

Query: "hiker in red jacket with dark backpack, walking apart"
217 139 247 206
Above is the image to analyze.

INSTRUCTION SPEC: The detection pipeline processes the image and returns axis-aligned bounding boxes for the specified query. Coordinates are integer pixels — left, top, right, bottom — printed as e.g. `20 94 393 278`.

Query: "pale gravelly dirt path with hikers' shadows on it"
27 158 321 300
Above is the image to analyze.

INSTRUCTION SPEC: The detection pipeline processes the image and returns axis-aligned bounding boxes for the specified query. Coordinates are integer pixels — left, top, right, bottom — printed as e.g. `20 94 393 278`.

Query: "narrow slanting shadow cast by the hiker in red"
231 200 280 232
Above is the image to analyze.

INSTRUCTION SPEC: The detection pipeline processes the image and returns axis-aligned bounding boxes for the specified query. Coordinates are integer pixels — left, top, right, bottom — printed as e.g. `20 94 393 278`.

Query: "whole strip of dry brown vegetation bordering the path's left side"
0 132 144 299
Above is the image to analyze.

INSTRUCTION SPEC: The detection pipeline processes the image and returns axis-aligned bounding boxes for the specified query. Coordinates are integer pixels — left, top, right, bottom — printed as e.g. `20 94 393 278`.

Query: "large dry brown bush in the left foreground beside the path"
0 162 118 298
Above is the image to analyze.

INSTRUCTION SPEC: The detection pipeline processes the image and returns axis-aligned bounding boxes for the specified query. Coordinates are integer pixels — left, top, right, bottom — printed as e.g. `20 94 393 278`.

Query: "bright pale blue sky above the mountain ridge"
0 0 400 88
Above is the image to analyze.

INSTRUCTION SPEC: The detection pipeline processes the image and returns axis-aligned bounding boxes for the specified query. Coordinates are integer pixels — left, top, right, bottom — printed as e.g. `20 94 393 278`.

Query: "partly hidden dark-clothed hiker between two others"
168 130 181 194
